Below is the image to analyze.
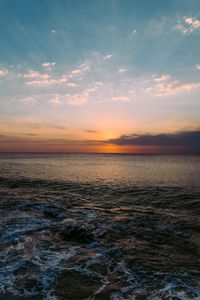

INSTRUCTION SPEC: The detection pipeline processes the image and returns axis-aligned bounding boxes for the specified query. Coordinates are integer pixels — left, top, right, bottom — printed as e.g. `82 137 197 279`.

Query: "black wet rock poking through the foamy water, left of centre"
61 224 94 243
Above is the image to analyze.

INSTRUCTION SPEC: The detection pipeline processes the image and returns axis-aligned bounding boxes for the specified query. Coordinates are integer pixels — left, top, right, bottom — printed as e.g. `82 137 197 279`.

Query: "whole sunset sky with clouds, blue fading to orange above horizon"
0 0 200 153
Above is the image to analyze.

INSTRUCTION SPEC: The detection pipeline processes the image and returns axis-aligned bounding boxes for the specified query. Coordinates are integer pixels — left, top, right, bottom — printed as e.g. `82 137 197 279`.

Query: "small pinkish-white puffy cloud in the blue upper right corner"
175 17 200 34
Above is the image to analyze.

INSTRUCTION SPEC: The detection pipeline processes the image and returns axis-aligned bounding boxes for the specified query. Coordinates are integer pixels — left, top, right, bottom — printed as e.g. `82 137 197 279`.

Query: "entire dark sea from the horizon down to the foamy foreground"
0 154 200 300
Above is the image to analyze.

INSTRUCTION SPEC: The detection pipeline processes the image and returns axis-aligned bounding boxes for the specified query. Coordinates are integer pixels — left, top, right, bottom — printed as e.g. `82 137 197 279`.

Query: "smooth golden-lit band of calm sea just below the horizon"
0 154 200 188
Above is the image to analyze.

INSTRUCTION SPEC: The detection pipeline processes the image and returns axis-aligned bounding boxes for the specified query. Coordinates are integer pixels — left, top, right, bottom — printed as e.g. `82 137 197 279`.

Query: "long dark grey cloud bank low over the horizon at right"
106 130 200 153
